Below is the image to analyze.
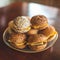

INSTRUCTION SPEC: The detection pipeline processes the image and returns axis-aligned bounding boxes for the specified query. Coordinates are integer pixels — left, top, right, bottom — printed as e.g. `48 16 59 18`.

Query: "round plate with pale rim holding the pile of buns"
3 28 58 53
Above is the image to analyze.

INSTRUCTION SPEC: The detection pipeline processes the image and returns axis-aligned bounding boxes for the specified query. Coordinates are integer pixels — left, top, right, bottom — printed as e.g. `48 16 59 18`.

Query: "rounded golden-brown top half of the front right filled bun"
28 34 47 43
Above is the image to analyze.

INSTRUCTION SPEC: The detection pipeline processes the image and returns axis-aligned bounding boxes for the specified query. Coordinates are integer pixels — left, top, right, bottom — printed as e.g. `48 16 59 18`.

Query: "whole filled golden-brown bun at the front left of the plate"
8 33 26 49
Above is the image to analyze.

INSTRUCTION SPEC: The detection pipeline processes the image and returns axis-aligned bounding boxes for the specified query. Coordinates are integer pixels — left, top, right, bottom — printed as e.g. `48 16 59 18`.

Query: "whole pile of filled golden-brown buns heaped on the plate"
8 15 57 51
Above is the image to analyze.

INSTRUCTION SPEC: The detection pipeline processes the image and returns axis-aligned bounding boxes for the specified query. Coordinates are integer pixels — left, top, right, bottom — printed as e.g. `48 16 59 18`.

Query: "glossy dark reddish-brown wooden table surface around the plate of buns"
0 2 60 60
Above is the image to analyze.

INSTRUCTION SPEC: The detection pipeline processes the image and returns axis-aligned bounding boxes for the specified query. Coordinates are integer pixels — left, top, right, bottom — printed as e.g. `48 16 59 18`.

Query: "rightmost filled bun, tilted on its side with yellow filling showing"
40 25 57 42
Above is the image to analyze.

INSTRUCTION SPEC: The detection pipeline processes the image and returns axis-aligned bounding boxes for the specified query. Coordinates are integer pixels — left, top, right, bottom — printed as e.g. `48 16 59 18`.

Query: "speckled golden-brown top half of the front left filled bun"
9 33 26 43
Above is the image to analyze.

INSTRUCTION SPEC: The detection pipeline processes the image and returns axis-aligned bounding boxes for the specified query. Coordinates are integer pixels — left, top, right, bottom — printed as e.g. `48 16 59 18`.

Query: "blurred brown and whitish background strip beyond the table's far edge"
0 0 60 8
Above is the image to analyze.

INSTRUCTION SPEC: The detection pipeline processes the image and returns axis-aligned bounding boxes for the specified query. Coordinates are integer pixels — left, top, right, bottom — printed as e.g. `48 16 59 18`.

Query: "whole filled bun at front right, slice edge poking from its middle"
27 34 47 51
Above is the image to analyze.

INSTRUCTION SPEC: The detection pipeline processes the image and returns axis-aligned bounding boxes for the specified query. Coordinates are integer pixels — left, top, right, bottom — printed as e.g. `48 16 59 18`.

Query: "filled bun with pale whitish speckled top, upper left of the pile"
9 16 31 33
